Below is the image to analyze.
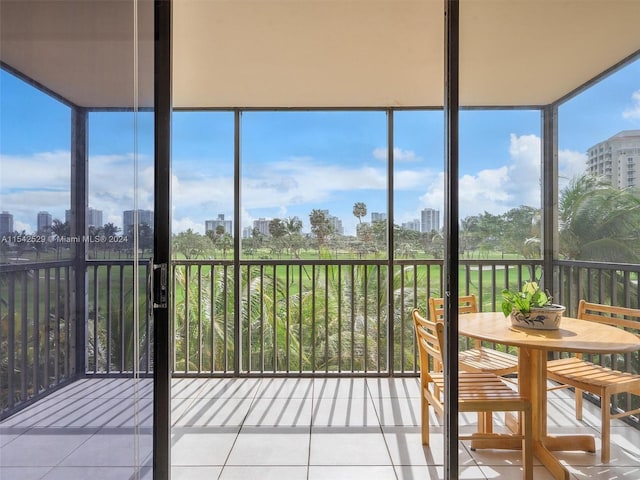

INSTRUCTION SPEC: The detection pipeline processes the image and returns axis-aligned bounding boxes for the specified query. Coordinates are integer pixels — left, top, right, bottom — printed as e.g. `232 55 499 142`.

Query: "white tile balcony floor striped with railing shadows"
0 378 640 480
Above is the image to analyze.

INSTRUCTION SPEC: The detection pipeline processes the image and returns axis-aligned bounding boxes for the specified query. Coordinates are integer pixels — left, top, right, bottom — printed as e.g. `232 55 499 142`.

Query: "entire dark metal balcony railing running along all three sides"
0 260 640 423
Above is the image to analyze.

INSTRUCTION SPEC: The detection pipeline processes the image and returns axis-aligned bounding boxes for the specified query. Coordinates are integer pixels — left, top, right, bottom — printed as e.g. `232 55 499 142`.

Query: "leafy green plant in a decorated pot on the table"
502 281 565 330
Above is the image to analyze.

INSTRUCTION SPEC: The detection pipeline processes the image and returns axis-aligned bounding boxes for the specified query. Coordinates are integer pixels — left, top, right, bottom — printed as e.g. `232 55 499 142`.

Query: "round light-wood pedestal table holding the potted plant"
458 312 640 480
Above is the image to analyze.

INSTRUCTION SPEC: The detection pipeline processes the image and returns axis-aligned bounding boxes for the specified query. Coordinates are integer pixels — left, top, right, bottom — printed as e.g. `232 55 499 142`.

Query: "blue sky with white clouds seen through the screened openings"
0 60 640 234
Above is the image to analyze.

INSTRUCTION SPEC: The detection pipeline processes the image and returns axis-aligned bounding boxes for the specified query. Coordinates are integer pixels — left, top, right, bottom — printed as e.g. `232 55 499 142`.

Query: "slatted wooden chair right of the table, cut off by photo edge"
547 300 640 463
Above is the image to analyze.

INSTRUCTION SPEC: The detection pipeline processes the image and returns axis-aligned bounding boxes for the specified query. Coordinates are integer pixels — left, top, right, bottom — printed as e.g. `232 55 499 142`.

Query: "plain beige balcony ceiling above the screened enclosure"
0 0 640 107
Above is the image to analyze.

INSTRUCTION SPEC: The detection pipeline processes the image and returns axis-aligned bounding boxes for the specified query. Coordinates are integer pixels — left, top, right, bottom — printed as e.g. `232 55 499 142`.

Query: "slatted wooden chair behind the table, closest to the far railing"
429 295 518 376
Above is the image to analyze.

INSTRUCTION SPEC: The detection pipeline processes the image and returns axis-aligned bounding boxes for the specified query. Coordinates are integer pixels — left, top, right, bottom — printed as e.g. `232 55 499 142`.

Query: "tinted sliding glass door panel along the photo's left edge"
0 0 154 479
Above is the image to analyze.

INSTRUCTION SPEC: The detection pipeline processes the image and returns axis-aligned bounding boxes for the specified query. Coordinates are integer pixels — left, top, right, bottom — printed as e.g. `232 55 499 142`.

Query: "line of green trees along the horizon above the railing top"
1 174 640 263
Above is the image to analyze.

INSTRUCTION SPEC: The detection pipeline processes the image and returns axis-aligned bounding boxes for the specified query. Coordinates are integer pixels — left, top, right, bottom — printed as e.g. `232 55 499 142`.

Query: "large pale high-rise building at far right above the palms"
587 130 640 188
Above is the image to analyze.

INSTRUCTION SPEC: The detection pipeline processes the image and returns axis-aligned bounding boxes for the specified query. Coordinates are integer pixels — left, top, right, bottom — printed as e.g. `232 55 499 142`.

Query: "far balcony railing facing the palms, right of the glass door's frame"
173 260 541 376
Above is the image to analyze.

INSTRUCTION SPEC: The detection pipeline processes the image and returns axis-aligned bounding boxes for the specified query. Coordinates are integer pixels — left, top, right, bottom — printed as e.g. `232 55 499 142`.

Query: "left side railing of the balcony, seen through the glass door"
0 261 75 413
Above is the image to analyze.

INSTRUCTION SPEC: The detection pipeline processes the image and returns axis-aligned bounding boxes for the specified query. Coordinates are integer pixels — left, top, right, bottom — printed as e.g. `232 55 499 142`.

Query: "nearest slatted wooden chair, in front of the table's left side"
412 309 533 480
